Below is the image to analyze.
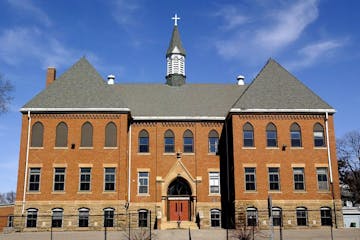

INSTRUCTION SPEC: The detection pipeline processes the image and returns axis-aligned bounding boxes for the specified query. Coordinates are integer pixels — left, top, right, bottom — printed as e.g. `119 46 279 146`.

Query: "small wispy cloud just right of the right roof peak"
287 40 346 69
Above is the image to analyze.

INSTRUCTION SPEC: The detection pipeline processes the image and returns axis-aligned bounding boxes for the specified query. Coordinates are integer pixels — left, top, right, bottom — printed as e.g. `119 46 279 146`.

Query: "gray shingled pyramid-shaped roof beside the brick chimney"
21 57 129 111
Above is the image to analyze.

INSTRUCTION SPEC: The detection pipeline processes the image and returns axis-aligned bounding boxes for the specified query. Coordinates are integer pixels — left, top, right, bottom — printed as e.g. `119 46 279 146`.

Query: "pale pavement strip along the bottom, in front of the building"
0 229 360 240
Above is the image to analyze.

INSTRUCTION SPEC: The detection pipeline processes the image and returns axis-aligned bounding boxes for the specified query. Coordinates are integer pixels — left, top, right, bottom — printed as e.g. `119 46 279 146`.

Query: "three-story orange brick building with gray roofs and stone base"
14 18 342 231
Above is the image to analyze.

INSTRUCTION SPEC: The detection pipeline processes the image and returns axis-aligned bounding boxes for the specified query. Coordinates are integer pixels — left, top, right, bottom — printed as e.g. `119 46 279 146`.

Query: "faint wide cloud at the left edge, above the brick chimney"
0 27 95 68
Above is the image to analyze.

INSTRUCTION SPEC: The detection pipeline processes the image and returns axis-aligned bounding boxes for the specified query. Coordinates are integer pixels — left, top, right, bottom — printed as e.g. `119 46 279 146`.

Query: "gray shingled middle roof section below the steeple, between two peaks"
116 84 246 118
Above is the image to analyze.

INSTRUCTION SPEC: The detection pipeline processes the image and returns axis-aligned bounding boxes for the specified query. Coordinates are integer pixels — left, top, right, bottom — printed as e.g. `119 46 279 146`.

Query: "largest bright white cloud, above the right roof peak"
215 0 319 62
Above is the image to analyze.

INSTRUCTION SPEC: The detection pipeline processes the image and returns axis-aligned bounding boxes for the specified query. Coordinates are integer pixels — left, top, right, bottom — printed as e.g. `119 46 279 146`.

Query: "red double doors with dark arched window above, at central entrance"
167 177 192 221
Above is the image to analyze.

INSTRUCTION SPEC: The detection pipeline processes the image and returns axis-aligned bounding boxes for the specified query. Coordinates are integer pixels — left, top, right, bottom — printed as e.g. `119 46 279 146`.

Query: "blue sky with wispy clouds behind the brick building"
0 0 360 192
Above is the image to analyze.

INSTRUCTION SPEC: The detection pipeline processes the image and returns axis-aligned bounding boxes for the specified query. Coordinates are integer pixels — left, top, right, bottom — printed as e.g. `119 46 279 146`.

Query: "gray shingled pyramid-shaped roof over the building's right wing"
231 59 335 112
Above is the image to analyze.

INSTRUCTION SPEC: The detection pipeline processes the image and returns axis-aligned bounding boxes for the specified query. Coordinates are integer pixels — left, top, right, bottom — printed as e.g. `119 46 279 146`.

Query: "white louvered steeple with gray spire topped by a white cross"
166 14 186 86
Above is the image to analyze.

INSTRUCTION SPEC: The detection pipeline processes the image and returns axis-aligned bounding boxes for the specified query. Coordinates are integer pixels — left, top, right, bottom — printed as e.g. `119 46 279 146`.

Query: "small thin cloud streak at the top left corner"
8 0 52 26
